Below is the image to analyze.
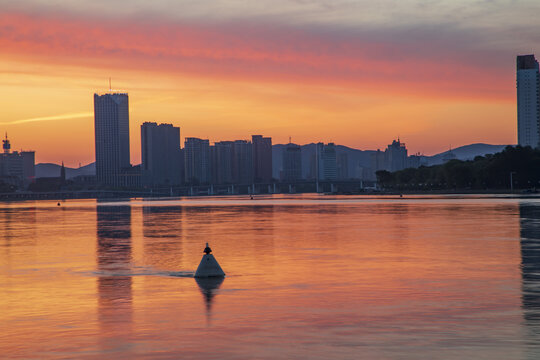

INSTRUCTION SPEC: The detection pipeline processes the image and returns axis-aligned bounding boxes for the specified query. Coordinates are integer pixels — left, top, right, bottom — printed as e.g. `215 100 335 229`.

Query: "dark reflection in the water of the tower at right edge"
519 204 540 341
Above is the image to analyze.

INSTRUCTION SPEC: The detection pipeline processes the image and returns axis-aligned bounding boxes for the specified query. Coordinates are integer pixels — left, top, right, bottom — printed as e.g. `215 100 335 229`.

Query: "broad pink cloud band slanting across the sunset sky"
0 12 514 99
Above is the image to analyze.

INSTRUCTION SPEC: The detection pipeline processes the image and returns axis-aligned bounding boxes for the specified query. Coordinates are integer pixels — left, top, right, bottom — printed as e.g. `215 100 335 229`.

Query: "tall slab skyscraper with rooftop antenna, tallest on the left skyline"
94 93 131 187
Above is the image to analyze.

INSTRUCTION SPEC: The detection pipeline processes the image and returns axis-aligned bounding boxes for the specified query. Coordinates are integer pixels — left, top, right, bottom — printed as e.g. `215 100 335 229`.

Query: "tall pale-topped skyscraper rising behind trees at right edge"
516 55 540 148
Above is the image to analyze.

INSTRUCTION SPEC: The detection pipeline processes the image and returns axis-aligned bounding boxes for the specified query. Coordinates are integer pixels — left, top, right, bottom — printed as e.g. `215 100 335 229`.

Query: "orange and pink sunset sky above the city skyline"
0 0 540 166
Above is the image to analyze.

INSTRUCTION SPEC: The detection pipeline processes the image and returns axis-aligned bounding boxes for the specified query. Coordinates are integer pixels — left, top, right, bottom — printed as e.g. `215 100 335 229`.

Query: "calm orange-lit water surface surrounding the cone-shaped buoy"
0 195 540 359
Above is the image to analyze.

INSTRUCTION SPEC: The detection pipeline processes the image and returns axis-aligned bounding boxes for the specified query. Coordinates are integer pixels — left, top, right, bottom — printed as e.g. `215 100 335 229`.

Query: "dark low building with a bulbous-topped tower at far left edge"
0 134 35 187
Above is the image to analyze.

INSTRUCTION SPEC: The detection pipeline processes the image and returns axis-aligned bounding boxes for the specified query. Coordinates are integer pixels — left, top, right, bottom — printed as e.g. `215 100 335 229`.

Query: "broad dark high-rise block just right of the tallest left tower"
141 122 183 186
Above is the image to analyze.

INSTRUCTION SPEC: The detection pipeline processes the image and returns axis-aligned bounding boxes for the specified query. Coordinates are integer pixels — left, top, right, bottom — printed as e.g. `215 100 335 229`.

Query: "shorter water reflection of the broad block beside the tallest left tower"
142 206 182 270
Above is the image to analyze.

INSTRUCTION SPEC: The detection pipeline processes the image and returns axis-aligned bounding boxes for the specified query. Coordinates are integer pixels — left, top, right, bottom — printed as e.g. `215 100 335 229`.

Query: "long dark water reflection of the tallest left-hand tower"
96 205 132 347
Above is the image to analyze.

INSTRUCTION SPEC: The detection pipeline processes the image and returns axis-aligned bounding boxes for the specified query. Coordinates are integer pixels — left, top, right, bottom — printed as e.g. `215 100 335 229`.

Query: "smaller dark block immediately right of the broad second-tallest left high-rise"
184 138 211 184
